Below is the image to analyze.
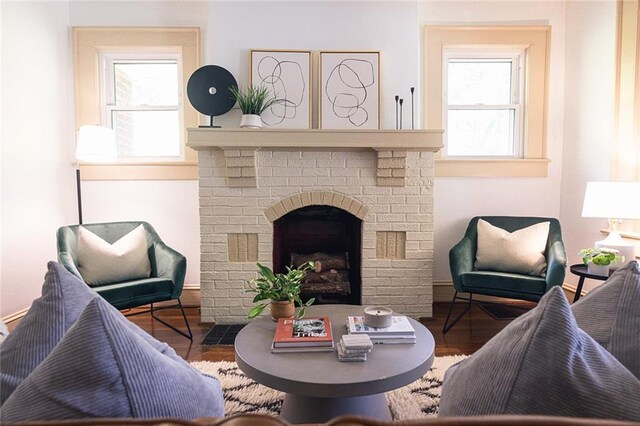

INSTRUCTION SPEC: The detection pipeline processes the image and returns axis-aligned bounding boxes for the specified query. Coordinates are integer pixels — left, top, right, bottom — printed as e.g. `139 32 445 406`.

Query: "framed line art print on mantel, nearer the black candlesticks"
319 51 380 129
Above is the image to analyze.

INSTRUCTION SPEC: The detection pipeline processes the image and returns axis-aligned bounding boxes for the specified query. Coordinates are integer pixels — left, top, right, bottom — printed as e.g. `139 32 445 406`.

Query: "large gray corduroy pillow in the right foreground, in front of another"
440 287 640 421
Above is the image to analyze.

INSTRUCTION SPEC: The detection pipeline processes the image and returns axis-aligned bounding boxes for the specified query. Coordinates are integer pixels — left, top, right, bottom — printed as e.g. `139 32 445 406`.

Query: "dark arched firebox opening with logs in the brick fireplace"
273 205 362 305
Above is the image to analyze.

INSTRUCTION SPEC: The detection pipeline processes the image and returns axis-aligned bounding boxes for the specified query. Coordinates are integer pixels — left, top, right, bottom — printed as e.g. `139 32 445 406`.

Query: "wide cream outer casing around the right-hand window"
423 25 551 177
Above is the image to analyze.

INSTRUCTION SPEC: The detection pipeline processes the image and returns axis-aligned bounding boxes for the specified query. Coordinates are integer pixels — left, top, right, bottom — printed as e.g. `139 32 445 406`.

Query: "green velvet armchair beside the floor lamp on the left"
57 222 193 339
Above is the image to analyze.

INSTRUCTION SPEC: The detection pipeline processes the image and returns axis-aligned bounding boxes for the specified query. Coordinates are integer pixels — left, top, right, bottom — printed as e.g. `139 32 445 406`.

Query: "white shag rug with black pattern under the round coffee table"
191 355 467 420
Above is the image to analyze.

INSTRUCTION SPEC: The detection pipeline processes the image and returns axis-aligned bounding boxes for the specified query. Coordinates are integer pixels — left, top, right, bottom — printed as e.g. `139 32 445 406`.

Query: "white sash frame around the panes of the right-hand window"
442 46 526 160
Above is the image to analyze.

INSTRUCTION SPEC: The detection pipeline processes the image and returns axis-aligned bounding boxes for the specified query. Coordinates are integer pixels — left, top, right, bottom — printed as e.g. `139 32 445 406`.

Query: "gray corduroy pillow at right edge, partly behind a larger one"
571 260 640 378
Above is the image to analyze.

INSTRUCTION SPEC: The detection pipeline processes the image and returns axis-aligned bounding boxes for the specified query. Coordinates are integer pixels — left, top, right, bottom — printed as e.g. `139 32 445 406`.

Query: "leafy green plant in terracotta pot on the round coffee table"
245 262 315 321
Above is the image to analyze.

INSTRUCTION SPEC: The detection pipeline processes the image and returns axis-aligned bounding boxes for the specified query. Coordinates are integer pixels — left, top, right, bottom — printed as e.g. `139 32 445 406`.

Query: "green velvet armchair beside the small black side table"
443 216 567 333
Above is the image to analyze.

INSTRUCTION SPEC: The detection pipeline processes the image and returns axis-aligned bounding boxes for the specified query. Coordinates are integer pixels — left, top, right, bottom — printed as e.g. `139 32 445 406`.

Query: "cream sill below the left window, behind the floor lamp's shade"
80 163 198 180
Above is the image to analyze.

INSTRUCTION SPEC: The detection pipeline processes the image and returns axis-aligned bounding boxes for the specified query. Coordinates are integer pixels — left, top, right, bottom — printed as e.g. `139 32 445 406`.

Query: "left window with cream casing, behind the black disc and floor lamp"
73 27 200 180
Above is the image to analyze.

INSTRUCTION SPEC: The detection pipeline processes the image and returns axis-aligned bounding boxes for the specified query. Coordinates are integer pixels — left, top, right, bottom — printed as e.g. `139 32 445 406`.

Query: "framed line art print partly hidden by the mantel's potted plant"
249 49 311 129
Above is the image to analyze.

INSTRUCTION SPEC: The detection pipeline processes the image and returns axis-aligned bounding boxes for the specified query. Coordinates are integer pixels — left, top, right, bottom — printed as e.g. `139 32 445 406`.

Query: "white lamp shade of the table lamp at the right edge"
582 182 640 219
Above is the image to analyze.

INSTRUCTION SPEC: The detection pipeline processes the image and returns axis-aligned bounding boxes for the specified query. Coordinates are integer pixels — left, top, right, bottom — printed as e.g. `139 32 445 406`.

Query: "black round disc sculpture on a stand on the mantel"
187 65 238 127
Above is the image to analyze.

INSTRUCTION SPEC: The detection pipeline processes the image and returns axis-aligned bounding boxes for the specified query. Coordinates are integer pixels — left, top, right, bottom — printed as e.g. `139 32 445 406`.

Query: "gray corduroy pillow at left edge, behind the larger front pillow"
0 262 99 405
